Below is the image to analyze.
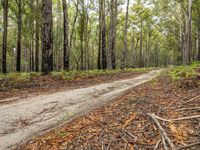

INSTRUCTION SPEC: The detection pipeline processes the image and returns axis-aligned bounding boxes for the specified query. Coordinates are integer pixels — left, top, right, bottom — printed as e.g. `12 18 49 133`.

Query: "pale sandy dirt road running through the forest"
0 69 163 150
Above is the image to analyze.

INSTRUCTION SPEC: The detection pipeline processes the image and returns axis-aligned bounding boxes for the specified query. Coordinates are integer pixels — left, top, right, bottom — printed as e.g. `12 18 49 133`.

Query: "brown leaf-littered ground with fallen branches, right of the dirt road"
19 64 200 150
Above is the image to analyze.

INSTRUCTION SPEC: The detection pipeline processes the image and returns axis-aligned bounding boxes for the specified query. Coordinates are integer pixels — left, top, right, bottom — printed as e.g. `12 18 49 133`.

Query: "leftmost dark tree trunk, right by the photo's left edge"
2 0 8 73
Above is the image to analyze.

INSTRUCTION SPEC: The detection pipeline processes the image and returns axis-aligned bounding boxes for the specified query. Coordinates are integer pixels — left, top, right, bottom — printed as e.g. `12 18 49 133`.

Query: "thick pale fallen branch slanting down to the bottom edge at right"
148 113 175 150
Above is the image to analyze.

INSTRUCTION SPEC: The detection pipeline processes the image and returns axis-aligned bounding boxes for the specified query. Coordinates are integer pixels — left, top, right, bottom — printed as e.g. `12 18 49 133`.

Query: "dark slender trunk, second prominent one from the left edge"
16 0 22 72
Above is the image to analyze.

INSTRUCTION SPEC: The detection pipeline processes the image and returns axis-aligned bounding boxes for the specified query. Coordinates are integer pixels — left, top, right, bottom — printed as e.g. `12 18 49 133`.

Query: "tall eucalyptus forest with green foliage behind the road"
0 0 200 73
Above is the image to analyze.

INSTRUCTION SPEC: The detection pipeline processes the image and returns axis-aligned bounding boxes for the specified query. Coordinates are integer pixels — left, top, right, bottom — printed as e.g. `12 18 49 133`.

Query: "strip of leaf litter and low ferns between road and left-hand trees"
0 68 148 101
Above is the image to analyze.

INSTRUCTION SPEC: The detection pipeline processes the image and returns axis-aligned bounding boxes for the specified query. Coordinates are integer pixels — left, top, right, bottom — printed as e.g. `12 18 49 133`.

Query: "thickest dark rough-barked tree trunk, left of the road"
42 0 53 75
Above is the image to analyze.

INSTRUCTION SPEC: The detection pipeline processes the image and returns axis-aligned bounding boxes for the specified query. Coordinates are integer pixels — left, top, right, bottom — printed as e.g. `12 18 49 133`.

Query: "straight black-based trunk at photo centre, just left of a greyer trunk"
101 0 107 70
